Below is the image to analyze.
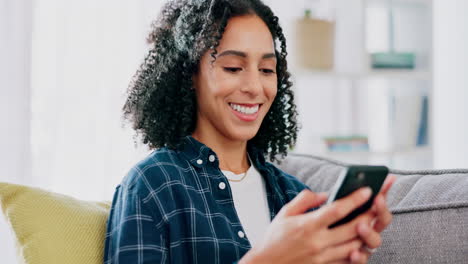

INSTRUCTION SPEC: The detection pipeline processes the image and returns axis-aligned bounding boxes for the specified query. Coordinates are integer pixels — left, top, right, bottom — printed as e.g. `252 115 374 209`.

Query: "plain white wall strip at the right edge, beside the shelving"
433 0 468 168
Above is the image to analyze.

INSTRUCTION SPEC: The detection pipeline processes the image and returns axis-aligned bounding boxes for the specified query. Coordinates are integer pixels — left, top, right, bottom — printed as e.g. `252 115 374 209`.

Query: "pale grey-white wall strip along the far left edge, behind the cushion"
0 0 32 264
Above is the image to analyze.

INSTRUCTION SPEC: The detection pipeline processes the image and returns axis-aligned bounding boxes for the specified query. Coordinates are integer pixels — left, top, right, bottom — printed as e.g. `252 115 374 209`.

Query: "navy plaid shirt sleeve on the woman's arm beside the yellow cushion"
104 186 169 264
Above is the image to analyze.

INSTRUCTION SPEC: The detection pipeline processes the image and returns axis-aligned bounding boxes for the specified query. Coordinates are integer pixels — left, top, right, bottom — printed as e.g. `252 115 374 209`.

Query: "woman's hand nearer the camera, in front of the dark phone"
239 188 374 264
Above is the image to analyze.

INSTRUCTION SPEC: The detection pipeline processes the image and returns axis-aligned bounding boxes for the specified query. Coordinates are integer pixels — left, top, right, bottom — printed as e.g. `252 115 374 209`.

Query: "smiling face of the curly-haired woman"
194 15 277 144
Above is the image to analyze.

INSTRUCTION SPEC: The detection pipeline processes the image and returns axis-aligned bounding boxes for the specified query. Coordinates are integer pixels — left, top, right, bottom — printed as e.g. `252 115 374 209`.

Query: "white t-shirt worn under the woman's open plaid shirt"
222 162 271 247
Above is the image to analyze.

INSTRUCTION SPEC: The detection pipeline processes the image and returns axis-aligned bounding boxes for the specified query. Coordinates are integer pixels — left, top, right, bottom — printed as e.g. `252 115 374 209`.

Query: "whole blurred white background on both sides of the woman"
0 0 468 263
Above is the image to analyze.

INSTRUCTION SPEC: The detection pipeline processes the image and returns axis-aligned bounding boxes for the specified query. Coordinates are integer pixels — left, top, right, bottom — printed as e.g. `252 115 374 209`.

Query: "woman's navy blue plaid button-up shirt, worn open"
104 136 307 264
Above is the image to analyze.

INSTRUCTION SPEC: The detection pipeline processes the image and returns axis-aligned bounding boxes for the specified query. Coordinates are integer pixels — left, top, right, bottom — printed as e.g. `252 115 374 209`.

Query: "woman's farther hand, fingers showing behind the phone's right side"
351 175 396 263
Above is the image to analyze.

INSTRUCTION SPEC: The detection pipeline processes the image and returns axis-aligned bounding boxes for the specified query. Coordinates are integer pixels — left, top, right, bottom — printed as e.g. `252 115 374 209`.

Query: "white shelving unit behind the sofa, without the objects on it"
290 0 434 169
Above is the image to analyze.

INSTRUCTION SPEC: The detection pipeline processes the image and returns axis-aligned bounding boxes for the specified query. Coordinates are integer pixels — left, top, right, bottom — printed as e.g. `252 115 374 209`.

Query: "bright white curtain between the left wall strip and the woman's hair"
31 0 162 200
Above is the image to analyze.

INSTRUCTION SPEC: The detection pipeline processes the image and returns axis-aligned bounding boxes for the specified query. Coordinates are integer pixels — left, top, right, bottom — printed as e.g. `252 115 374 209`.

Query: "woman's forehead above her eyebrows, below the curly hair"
217 15 275 54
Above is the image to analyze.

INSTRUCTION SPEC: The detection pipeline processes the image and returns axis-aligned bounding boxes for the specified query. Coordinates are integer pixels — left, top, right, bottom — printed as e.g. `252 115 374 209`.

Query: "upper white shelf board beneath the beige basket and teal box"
291 69 431 80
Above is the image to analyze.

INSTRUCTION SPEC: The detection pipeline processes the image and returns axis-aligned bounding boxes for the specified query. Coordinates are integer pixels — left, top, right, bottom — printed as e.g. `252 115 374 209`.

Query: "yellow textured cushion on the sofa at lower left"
0 182 110 264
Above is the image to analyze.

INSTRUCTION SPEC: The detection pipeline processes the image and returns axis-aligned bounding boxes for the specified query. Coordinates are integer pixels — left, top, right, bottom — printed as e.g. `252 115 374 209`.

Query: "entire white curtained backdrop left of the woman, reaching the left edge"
0 0 164 264
